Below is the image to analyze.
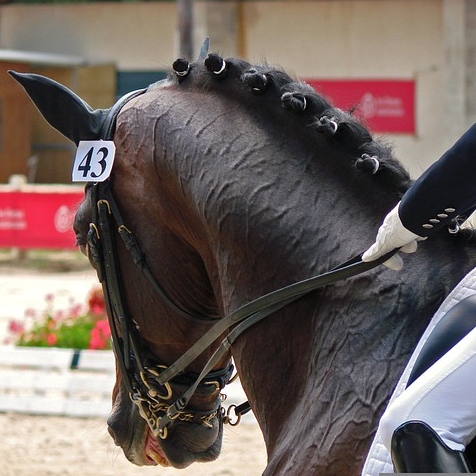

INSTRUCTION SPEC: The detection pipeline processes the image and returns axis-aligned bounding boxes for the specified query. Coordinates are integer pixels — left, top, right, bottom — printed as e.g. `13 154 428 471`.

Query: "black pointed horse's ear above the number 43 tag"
9 71 108 145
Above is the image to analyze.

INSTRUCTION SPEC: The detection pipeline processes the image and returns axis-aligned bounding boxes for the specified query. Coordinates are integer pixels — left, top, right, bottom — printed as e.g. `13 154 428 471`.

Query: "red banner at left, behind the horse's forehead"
0 185 84 249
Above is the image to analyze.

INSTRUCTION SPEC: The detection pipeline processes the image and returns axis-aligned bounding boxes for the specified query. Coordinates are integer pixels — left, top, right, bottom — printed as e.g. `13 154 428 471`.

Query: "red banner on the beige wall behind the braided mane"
305 79 415 134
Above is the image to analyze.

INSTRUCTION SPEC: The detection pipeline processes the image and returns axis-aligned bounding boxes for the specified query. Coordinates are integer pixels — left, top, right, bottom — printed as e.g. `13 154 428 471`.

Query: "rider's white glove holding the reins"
362 203 426 271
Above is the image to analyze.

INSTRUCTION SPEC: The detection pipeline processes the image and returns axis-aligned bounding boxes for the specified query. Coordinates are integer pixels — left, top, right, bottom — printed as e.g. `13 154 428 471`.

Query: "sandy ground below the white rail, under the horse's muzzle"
0 413 266 476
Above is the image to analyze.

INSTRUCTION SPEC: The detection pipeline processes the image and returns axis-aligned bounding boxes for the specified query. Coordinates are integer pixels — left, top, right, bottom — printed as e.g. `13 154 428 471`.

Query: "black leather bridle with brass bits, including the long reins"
84 86 396 439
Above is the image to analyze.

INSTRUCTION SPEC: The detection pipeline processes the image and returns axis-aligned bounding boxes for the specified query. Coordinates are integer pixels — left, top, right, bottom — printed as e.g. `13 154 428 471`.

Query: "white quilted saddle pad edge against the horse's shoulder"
362 269 476 476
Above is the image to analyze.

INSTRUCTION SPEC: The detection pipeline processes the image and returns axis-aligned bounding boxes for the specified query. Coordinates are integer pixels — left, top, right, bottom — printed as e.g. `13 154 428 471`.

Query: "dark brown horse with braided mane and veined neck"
11 45 476 476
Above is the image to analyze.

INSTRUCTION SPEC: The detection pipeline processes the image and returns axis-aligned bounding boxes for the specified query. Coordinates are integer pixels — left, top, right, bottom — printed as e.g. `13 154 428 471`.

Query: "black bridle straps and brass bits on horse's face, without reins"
88 181 233 438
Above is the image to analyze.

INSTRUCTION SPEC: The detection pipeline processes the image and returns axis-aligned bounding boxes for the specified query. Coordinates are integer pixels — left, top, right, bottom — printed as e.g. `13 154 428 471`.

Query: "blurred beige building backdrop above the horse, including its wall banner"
0 0 470 183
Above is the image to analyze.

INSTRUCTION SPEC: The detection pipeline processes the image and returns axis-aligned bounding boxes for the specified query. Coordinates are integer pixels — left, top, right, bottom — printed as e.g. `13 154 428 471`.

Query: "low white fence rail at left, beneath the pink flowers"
0 346 115 417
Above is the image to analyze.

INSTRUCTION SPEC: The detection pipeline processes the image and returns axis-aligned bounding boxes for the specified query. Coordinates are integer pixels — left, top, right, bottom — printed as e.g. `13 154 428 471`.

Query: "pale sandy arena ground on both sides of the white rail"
0 256 266 476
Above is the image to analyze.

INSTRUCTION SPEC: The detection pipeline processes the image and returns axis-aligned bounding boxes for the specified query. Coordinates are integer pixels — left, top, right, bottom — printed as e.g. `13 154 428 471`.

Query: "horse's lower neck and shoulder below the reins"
226 231 476 474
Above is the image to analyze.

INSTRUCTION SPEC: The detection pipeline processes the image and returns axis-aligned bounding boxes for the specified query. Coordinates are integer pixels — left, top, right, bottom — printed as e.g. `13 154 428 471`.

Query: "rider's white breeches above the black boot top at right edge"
380 329 476 451
